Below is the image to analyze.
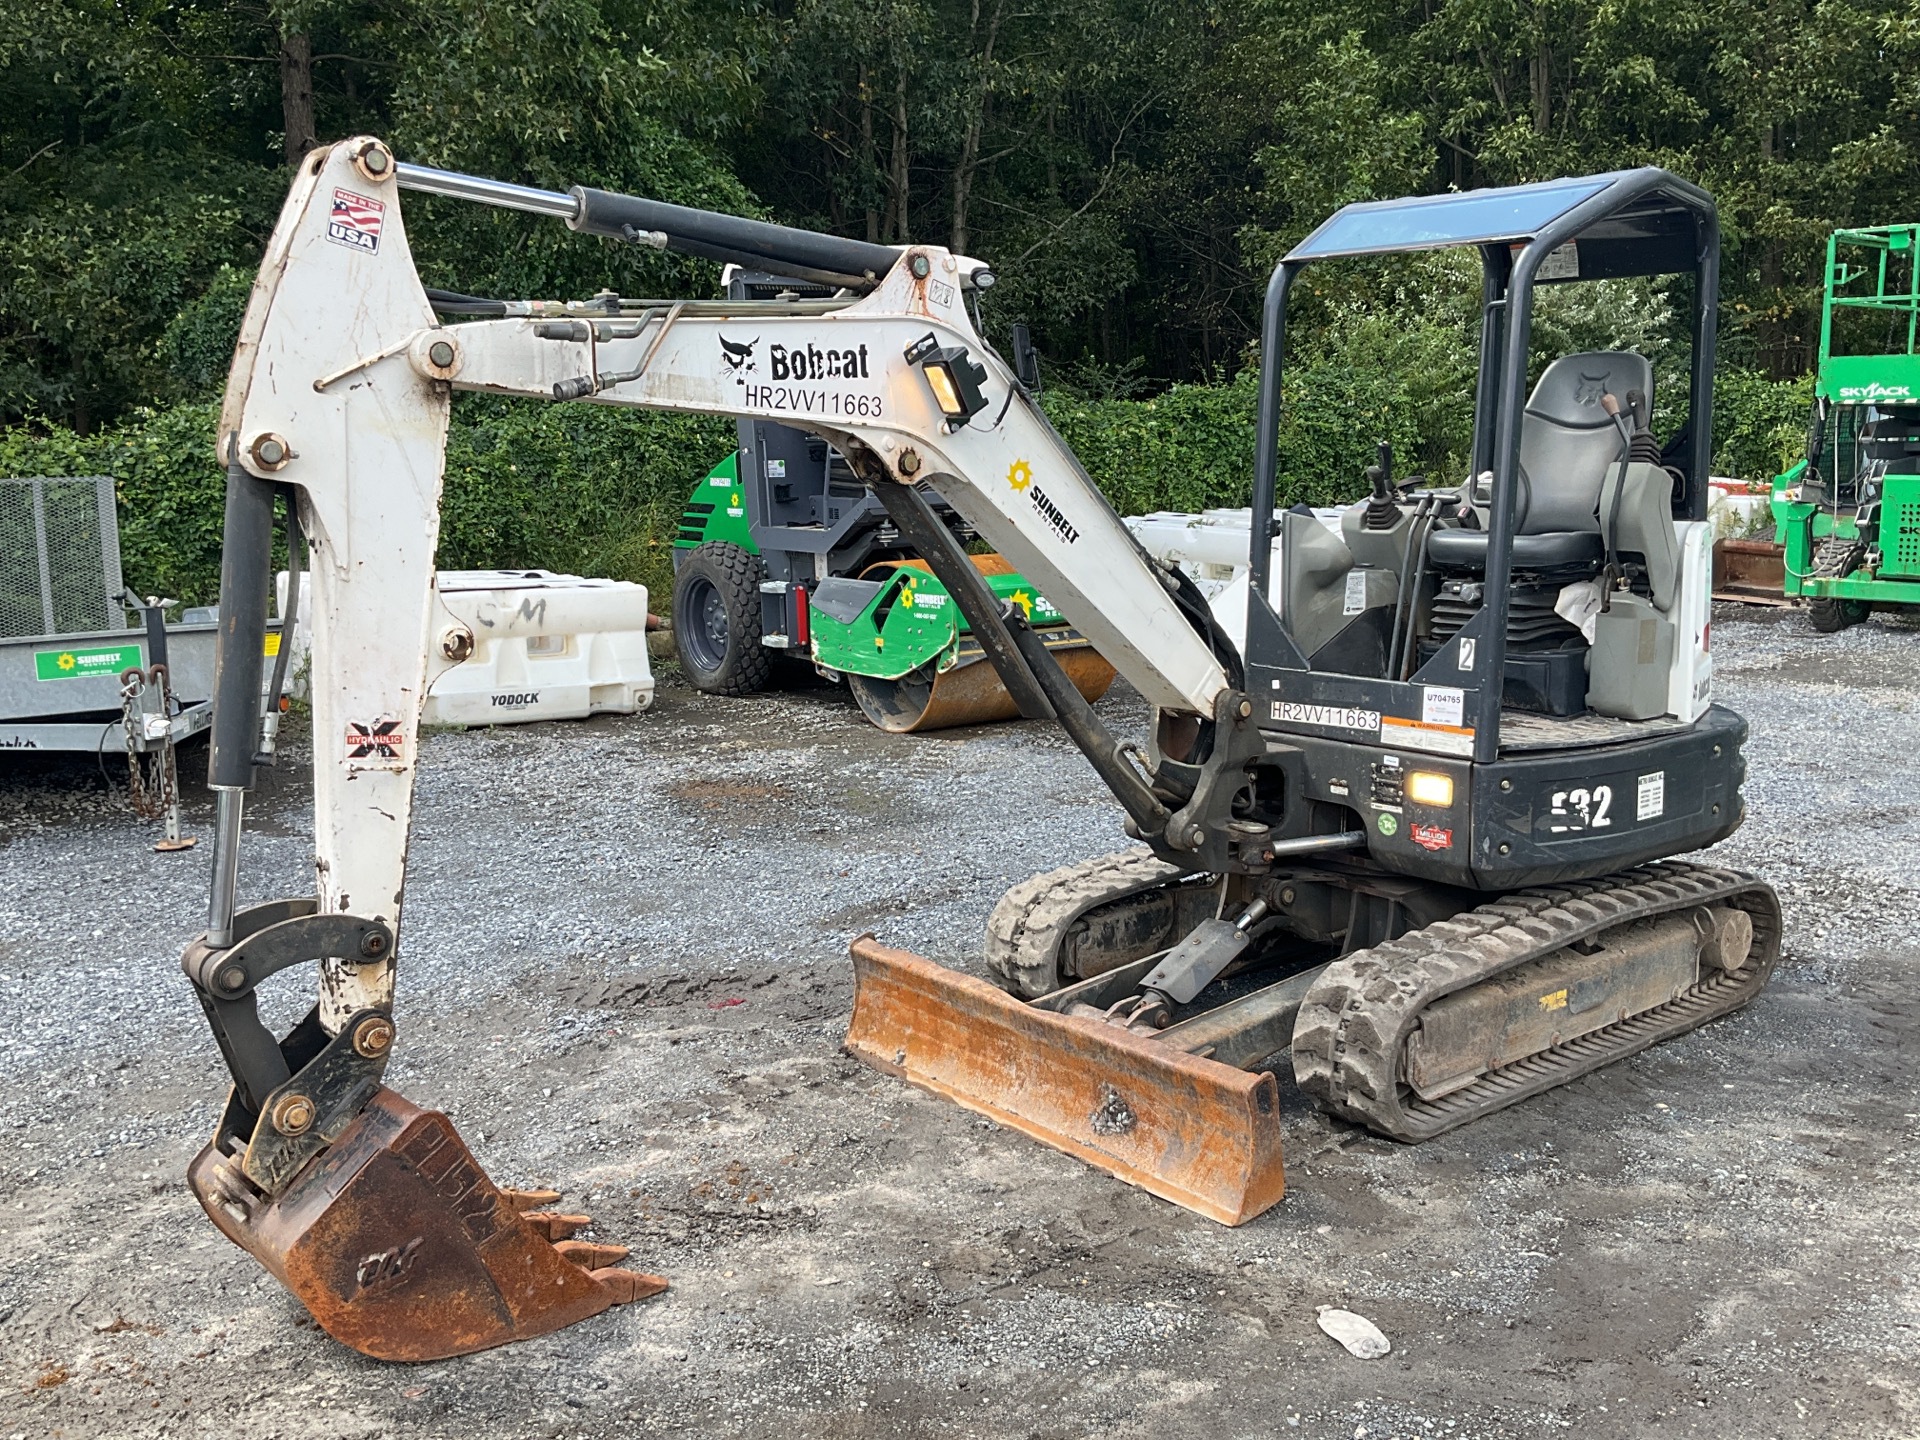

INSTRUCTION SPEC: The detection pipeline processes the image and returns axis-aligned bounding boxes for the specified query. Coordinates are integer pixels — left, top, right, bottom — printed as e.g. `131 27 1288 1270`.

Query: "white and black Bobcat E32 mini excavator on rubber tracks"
184 138 1780 1359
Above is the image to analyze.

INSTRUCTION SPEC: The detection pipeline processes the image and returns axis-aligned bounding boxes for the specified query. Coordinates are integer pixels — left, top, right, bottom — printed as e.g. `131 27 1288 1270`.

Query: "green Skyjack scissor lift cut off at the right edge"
1772 225 1920 632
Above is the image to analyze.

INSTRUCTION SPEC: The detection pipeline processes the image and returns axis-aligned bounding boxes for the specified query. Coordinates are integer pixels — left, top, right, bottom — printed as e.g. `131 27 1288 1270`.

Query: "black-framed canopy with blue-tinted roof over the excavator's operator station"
1246 167 1720 762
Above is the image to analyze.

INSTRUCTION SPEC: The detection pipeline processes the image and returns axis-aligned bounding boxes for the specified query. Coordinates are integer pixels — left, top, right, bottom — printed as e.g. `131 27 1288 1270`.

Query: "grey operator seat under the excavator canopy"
1427 349 1653 570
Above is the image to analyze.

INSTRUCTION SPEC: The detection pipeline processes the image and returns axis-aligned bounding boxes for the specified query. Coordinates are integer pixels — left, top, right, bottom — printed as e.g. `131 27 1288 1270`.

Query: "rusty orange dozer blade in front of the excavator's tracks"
847 948 1286 1225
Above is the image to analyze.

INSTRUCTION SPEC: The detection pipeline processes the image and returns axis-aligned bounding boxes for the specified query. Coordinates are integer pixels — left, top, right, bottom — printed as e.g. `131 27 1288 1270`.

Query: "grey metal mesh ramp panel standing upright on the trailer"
0 476 127 639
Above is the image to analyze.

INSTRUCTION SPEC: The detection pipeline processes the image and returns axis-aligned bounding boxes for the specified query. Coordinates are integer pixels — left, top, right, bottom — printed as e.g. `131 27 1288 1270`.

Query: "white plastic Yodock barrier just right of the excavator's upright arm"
420 570 653 726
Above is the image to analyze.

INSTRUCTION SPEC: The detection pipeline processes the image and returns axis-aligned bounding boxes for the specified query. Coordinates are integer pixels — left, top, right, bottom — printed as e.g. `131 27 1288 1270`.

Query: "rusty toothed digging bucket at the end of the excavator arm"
188 1089 666 1359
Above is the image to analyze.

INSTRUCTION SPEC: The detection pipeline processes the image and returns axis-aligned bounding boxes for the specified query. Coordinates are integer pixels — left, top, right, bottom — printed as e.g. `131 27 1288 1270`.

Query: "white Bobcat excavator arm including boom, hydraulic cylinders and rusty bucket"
184 138 1236 1359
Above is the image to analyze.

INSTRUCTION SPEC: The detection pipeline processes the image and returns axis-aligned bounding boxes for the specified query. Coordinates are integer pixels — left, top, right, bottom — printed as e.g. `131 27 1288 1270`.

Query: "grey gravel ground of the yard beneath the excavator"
0 611 1920 1440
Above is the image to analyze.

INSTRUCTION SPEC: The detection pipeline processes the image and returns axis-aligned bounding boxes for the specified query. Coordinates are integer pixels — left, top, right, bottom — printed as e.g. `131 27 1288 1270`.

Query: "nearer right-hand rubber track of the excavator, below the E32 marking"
1294 862 1780 1142
